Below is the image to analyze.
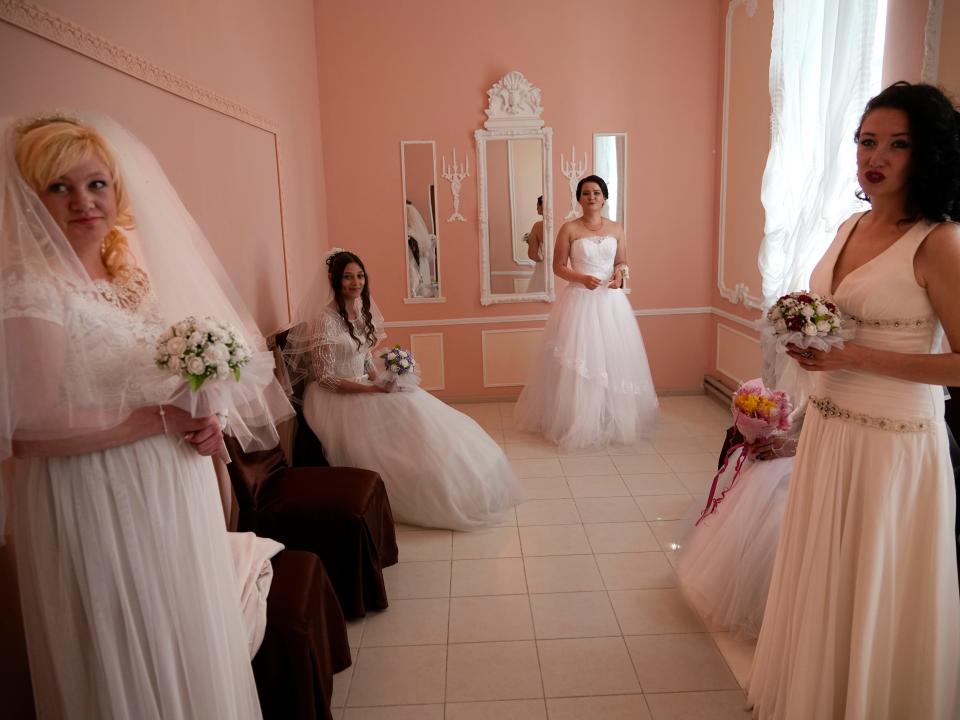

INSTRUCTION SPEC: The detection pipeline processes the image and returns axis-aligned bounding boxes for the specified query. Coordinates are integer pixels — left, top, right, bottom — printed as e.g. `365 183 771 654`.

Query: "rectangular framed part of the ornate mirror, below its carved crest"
476 128 553 305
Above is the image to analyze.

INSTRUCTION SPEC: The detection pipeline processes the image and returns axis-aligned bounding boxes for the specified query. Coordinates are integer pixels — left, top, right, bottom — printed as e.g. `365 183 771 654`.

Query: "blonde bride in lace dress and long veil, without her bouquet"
0 116 292 720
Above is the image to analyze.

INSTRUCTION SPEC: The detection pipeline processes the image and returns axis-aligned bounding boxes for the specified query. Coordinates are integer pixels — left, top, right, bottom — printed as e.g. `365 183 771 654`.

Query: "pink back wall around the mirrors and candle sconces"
316 0 721 397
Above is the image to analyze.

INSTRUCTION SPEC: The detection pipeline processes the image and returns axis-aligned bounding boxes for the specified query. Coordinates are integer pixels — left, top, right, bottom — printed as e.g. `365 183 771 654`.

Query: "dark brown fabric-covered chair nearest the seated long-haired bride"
225 437 397 618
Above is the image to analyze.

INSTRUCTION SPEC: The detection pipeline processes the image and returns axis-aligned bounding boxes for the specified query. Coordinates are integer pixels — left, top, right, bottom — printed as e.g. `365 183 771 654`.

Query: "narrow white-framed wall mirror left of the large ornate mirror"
400 140 443 302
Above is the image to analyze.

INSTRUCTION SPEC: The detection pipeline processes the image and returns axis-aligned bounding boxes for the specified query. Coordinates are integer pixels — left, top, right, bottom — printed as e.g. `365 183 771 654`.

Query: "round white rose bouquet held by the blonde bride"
156 316 253 392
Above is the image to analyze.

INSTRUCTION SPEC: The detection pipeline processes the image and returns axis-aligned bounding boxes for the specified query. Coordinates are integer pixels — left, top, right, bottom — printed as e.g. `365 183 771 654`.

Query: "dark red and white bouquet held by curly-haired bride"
759 291 855 352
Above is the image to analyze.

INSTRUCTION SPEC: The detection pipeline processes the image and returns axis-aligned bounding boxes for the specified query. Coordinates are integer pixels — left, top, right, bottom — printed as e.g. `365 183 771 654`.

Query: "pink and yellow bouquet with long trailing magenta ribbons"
696 378 791 525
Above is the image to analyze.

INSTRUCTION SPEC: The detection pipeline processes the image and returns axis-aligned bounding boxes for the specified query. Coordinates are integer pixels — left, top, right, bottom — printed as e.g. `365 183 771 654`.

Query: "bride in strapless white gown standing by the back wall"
514 175 658 449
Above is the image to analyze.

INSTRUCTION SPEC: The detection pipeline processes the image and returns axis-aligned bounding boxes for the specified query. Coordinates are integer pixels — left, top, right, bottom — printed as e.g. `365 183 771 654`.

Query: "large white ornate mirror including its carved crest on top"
475 72 554 305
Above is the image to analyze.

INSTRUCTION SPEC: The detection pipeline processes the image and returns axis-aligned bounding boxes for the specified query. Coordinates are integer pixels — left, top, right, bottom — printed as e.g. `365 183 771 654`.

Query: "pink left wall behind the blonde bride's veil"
0 0 327 332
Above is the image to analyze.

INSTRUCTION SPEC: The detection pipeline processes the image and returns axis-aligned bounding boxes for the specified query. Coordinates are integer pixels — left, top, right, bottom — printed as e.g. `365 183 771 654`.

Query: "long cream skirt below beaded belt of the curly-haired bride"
749 406 960 720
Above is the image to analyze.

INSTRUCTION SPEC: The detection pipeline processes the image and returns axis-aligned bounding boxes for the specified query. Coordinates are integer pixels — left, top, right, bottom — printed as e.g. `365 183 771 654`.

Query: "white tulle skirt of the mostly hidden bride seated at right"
677 451 793 638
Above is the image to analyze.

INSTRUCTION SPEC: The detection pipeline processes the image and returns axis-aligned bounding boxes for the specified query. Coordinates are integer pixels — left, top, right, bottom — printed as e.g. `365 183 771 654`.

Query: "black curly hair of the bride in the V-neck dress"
854 81 960 222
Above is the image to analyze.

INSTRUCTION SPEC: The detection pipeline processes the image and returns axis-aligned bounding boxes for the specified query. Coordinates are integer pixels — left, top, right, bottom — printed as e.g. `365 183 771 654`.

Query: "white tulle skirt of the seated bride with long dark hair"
303 383 521 530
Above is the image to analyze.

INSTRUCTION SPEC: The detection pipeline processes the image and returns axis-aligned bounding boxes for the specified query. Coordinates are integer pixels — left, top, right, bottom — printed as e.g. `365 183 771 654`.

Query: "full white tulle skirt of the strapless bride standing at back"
513 284 657 448
